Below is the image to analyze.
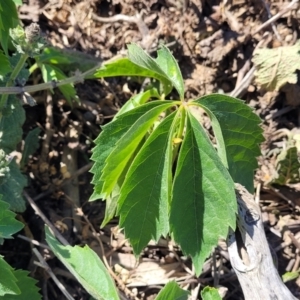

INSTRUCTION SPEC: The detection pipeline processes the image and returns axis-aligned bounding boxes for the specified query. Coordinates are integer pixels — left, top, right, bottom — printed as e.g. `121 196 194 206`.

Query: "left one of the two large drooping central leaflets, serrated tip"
118 113 175 254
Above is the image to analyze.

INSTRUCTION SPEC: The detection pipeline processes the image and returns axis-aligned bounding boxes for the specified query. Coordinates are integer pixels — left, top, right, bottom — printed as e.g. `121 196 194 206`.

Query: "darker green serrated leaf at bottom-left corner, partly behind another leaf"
1 270 42 300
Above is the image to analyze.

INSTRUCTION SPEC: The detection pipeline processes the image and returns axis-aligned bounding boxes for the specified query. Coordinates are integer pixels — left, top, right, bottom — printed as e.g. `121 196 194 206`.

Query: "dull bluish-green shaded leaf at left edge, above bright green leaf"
0 160 27 212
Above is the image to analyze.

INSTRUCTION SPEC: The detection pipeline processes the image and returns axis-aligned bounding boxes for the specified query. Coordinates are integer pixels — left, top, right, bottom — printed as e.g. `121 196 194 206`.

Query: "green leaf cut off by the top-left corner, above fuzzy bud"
0 0 19 55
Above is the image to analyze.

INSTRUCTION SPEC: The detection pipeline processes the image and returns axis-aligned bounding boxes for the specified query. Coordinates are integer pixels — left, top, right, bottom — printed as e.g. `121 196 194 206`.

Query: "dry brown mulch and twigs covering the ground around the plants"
0 0 300 299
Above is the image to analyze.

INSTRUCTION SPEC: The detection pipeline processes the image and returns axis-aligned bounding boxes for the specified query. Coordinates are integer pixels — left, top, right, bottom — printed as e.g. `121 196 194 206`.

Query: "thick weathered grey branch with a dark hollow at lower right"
227 184 297 300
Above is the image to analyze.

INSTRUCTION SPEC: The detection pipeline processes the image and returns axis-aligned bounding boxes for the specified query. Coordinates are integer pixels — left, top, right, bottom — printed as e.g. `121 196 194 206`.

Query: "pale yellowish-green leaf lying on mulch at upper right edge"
252 40 300 91
